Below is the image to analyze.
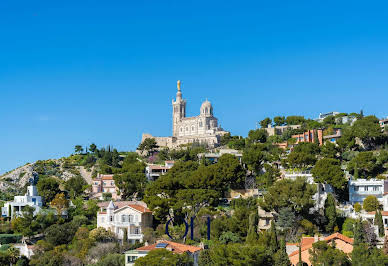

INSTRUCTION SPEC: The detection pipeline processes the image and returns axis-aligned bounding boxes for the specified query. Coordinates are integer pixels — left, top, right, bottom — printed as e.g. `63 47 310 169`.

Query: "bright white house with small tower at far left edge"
1 185 43 218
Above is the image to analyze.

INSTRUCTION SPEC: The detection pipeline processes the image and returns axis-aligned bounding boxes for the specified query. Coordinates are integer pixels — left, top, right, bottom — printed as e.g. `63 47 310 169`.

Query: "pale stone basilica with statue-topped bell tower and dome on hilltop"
142 80 228 148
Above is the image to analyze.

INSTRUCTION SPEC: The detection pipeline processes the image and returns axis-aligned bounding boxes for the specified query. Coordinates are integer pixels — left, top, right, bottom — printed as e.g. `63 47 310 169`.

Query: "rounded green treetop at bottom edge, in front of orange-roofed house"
135 248 191 266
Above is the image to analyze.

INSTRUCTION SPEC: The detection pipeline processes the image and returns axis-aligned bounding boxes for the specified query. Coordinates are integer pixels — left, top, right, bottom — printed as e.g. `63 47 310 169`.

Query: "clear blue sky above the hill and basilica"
0 0 388 173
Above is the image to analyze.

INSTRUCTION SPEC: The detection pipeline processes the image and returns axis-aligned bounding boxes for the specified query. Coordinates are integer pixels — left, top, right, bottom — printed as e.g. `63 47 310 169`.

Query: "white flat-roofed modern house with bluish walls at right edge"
349 178 385 204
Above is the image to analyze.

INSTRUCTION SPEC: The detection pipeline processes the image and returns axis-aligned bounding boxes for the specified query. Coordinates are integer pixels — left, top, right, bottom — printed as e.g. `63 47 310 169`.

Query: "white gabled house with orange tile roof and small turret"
97 201 152 243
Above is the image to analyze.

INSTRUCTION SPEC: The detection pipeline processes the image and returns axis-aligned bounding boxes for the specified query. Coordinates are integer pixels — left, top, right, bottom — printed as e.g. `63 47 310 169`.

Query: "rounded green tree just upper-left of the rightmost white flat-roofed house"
311 158 347 189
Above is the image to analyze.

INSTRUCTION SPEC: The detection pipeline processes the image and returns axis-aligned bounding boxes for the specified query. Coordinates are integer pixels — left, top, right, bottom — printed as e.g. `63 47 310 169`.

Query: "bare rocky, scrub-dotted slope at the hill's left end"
0 159 93 192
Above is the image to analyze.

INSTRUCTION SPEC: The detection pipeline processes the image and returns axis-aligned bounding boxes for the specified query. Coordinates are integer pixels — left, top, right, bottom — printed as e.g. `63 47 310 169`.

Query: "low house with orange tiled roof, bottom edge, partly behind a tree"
125 240 202 266
